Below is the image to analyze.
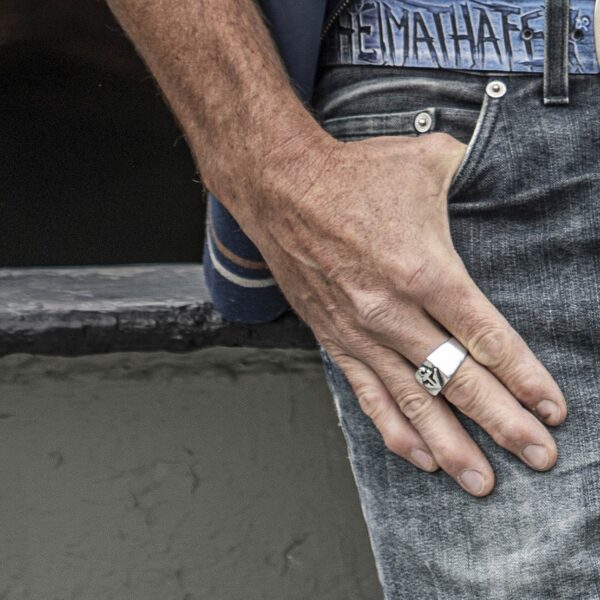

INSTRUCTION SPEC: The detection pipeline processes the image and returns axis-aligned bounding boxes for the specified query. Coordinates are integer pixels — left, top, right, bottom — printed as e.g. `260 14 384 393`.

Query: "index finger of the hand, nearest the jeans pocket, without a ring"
423 263 567 425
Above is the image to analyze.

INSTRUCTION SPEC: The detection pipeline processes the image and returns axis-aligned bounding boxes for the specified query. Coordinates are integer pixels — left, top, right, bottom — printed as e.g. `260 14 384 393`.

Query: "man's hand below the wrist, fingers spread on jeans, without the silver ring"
252 133 567 496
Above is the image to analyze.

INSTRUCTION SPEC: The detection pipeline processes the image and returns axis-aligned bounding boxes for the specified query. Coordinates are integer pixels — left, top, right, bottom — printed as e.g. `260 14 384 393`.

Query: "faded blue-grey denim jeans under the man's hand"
316 66 600 600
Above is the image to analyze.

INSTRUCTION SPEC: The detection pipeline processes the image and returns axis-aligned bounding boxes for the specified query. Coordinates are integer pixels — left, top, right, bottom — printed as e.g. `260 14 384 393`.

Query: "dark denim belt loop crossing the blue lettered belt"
544 0 569 104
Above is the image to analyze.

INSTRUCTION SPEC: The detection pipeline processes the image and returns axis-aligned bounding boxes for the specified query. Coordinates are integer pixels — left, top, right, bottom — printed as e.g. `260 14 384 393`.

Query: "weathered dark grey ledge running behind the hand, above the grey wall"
0 264 315 356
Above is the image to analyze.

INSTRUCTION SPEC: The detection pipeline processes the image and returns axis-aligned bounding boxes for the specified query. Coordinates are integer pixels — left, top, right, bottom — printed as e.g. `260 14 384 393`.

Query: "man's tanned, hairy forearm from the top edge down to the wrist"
109 0 333 237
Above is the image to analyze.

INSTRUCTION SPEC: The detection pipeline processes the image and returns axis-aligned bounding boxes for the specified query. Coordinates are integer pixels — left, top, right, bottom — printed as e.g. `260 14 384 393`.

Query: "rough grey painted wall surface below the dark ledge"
0 348 381 600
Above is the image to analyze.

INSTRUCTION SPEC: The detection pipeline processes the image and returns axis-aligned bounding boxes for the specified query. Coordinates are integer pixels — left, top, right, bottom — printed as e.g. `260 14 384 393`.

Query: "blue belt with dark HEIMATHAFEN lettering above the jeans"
322 0 600 73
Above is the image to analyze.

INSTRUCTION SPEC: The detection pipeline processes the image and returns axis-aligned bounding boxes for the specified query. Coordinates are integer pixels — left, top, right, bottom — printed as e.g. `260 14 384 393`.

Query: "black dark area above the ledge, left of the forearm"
0 0 204 266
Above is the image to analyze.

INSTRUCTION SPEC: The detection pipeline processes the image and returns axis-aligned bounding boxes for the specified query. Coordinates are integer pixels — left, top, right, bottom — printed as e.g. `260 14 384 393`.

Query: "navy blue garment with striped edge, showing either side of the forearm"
203 0 327 323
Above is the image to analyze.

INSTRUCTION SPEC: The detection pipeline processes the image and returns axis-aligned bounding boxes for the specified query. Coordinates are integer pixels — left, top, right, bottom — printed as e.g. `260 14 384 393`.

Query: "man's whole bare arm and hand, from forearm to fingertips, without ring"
109 0 567 496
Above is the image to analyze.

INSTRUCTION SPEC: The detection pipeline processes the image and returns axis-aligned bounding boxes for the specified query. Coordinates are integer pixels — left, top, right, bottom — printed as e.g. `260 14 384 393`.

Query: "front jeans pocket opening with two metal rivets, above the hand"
321 71 506 202
